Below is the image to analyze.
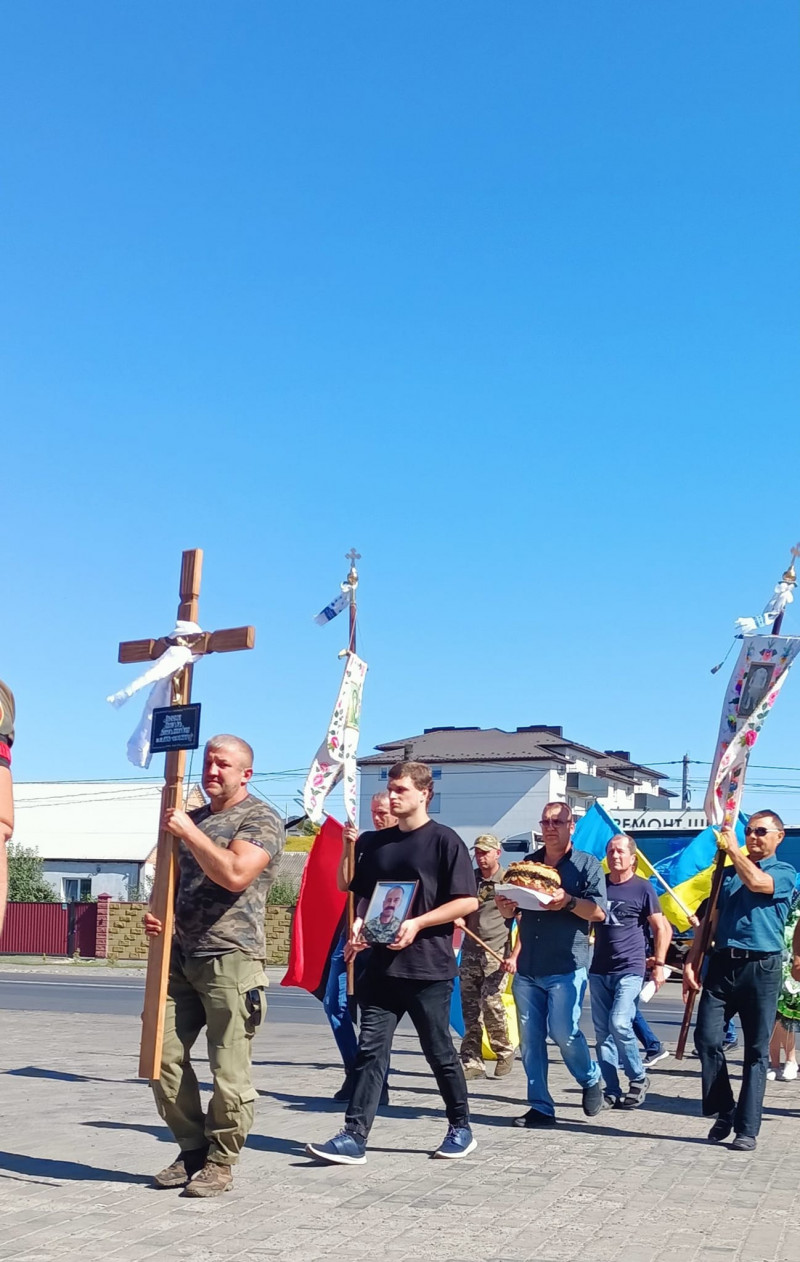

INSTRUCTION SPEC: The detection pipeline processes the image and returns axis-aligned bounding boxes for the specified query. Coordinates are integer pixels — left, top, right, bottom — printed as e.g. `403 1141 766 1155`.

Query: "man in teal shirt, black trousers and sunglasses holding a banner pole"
684 810 796 1152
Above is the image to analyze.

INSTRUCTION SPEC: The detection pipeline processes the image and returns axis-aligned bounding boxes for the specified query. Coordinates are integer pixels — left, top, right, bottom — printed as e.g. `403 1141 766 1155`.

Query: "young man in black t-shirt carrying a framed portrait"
305 762 478 1165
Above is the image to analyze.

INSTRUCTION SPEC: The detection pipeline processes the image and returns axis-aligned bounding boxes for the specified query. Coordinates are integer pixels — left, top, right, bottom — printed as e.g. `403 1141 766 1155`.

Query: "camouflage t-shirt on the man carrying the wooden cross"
175 795 285 959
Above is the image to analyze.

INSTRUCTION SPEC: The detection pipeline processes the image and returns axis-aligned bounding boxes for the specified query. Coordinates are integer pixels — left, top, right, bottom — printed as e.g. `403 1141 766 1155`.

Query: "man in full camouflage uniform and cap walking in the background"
459 833 514 1079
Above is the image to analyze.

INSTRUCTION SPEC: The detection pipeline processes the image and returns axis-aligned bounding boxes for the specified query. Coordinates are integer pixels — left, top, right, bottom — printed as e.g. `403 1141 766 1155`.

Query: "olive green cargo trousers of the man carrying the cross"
150 945 269 1165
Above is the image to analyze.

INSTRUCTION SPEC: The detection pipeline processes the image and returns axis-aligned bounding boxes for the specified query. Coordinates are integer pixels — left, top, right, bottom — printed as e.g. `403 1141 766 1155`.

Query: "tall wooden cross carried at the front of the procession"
113 548 256 1079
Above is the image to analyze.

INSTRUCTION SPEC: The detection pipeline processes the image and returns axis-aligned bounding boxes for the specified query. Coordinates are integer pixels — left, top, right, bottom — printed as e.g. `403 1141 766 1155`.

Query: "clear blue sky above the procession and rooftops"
0 0 800 822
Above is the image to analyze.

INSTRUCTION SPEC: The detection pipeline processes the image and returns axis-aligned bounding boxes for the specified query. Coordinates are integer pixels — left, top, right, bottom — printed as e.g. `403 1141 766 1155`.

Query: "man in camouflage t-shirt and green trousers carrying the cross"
145 736 284 1196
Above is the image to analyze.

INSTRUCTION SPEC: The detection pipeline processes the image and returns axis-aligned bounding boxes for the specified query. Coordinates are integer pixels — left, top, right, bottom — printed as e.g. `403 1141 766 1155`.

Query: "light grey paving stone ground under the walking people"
0 979 800 1262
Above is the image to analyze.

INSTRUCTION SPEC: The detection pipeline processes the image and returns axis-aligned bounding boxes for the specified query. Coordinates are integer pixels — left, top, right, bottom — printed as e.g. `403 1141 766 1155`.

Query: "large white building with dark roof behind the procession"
358 726 671 846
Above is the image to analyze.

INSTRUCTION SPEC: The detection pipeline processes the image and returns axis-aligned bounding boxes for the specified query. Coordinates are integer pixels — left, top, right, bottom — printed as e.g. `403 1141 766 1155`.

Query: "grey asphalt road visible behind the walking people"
0 972 683 1045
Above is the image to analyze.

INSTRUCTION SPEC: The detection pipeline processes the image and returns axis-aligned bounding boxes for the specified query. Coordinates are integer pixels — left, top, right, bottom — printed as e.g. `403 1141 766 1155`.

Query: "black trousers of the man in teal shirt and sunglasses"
694 952 781 1138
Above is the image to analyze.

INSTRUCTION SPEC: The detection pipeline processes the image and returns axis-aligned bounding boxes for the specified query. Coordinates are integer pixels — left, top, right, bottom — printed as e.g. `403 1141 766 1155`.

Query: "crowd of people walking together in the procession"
0 701 800 1198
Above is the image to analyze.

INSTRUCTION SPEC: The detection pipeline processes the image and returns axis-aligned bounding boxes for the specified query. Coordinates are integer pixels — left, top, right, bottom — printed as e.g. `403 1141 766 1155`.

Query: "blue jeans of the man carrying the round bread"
514 968 601 1117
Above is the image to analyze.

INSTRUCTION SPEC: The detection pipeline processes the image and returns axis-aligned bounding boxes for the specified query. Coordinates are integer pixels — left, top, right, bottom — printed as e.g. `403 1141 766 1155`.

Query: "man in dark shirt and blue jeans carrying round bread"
496 801 606 1128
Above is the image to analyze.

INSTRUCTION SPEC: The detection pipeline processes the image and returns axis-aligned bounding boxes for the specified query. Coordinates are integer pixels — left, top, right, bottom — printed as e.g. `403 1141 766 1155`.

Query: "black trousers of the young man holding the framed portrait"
344 973 469 1140
